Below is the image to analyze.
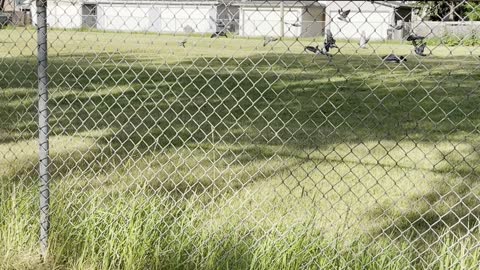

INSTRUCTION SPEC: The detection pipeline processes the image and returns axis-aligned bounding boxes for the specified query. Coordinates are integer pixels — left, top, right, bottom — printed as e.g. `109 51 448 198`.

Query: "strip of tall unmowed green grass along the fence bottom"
0 184 480 269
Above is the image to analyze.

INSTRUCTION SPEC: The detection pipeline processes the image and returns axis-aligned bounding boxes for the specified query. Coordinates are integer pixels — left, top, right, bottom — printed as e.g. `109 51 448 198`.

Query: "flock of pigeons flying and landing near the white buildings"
178 9 427 63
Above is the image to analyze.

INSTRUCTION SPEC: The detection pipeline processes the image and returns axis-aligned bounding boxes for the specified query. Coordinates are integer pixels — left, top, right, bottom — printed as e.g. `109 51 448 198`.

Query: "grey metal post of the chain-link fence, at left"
36 0 50 260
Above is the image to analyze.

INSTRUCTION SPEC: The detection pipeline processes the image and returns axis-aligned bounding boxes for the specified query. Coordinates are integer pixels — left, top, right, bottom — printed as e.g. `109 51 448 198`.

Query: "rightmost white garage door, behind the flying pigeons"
330 11 391 40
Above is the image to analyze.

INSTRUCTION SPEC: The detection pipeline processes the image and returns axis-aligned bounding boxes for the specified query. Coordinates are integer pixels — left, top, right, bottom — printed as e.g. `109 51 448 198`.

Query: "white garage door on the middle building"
241 8 302 37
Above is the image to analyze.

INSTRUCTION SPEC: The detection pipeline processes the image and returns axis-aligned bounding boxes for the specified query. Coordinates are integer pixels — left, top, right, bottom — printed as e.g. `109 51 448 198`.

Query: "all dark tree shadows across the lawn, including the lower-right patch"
0 50 480 247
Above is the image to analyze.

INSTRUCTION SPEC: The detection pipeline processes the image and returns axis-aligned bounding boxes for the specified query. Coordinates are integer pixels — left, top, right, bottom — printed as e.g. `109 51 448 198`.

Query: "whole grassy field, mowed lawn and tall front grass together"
0 29 480 269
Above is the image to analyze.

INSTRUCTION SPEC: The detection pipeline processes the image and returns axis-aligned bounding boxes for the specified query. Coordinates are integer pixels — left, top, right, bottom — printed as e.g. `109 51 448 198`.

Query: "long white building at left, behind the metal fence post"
31 0 238 33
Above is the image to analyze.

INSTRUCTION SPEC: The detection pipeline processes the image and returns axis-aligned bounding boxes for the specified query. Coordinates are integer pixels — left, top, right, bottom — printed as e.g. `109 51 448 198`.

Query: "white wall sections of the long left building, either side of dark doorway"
31 1 217 33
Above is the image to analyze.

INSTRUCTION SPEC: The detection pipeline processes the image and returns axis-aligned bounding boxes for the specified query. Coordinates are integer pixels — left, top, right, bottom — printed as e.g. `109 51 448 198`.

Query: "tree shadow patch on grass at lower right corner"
367 149 480 246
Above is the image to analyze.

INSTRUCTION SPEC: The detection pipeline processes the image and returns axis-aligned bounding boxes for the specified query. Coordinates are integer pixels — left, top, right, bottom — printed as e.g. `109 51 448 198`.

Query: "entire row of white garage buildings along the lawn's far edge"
31 0 411 40
